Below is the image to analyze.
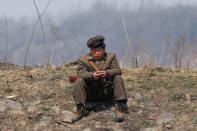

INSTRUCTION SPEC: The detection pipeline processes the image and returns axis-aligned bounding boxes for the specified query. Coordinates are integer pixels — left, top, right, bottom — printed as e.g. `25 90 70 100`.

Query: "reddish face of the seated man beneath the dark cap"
91 47 105 60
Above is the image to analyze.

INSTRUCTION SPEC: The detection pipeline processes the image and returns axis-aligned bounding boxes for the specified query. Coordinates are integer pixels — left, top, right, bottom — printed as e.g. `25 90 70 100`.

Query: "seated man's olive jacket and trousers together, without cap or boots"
73 53 127 104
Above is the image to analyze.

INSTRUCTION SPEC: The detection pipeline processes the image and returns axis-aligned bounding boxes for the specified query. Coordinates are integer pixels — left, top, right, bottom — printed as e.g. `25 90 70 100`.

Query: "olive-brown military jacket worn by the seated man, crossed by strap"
77 52 122 80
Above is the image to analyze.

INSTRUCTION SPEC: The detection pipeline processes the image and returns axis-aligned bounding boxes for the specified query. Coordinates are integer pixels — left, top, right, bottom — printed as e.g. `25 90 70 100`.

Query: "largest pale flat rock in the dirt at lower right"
157 112 174 122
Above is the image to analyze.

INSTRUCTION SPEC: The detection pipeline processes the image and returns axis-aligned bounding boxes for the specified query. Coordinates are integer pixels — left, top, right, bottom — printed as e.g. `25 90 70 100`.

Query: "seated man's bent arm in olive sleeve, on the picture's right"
106 55 122 77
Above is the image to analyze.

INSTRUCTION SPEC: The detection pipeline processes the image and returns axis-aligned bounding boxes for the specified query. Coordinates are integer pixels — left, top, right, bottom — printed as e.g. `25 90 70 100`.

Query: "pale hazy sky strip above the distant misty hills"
0 0 197 18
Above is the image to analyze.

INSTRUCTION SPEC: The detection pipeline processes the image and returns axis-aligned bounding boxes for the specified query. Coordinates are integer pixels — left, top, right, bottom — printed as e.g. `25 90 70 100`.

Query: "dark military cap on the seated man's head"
87 35 105 48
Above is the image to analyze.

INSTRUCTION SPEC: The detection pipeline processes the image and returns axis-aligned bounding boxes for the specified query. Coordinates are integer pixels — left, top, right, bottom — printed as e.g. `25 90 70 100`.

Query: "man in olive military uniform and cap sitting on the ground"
72 36 127 122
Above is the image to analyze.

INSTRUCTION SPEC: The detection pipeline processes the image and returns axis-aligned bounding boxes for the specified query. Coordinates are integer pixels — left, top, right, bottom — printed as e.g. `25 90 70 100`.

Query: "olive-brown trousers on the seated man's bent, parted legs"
73 75 127 104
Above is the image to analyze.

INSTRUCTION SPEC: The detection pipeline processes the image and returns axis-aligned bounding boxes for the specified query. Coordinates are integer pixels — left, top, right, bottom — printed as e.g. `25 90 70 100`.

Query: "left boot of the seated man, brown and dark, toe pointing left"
72 104 85 123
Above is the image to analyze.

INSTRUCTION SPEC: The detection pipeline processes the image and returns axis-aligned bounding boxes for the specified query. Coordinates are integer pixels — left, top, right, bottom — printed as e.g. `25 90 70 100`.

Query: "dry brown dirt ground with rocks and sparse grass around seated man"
0 63 197 131
